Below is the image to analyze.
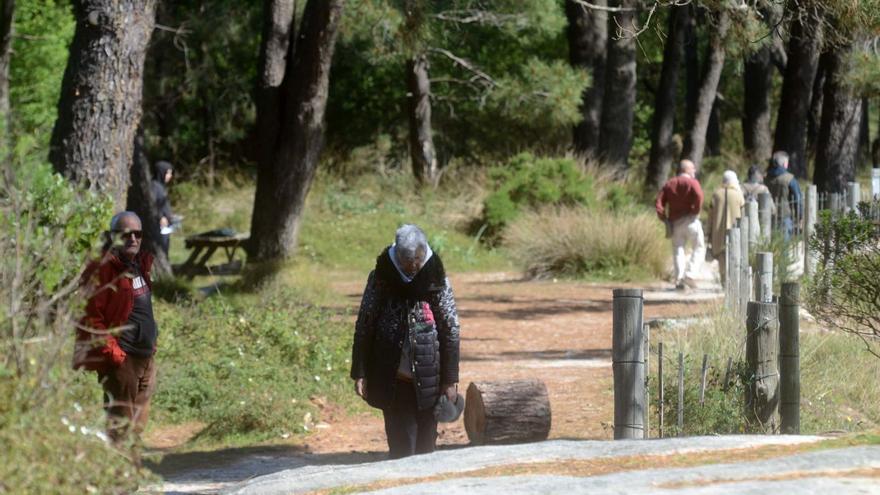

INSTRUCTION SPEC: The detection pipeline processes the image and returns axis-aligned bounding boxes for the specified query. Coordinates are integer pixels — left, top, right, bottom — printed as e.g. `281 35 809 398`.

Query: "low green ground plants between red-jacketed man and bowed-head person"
153 285 352 441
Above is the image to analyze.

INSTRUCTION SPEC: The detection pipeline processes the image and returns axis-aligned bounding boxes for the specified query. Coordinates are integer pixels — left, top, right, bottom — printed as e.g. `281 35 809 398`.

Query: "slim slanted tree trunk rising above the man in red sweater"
682 7 730 169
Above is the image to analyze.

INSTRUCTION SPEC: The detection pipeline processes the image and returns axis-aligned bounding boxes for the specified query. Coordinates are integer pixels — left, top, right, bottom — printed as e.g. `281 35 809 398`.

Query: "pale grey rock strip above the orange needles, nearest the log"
215 435 824 495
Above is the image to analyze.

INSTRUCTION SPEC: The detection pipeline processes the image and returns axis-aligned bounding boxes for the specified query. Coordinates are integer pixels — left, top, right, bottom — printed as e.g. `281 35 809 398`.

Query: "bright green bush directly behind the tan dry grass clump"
483 153 594 239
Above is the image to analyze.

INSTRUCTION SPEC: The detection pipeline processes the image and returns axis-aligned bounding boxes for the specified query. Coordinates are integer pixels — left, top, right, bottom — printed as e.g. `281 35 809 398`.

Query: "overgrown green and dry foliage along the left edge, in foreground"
0 164 150 494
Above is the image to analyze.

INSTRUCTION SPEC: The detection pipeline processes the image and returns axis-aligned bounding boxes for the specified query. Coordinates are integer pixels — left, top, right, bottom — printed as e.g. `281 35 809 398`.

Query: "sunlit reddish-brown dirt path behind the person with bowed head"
292 273 716 454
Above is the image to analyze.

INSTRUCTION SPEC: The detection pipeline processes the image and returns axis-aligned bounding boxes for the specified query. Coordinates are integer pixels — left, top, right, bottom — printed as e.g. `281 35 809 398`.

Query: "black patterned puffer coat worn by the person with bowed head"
351 248 459 410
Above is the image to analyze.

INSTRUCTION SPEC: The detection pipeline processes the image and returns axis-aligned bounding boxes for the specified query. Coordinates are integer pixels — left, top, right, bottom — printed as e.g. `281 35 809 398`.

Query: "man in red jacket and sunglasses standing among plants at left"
74 211 159 452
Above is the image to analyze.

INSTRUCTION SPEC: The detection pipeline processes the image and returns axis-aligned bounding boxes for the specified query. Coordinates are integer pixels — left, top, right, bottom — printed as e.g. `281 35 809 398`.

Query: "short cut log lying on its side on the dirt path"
464 380 550 445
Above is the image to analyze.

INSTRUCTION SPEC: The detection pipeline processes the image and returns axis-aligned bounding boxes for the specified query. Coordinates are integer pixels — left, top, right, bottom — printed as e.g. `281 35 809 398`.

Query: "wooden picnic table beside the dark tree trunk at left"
174 229 250 278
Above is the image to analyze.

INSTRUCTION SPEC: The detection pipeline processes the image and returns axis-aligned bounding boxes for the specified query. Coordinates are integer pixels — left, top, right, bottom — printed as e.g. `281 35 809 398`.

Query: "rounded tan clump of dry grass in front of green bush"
504 207 668 278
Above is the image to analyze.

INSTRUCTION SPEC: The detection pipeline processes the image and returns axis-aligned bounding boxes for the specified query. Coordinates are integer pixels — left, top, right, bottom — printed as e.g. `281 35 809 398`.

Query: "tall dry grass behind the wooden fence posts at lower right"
650 309 880 434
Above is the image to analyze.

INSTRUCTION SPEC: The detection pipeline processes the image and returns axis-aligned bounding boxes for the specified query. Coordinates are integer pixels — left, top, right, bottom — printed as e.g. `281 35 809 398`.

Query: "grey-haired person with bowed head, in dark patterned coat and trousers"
351 225 459 459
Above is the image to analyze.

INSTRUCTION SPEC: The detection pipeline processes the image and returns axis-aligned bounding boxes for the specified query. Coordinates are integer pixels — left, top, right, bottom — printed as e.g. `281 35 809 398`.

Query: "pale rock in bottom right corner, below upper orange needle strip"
364 446 880 495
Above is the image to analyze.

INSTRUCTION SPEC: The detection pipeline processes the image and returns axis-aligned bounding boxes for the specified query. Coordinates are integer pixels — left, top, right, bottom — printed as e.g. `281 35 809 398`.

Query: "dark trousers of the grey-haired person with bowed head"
382 380 437 459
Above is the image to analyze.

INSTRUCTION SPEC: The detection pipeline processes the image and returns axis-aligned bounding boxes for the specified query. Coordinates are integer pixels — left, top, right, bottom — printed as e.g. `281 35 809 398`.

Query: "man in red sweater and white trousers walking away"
655 160 706 289
